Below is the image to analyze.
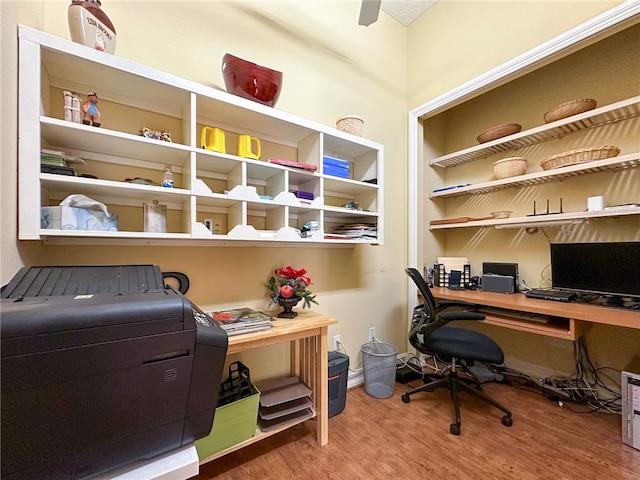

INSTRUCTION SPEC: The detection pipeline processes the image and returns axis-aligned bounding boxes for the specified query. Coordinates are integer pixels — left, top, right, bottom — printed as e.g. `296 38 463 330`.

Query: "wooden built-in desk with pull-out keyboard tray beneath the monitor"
431 287 640 340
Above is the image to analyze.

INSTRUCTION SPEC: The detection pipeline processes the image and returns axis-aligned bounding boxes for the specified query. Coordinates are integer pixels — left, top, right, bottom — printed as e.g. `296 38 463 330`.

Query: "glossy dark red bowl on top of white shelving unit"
222 53 282 107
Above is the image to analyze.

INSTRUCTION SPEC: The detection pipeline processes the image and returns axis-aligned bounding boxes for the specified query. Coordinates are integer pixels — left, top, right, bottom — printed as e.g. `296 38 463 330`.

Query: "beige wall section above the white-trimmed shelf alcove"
407 0 623 109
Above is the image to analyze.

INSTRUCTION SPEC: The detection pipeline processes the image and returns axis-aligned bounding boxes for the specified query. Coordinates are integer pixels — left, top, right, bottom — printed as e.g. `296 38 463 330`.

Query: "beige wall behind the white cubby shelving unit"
0 0 407 378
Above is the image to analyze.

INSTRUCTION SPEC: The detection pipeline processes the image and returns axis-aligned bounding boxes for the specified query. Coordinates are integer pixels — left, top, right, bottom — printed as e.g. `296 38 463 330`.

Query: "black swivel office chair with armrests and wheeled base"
402 268 513 435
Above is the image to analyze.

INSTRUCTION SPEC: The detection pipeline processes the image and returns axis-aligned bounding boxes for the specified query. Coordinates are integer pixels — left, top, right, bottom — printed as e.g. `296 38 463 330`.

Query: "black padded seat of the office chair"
429 327 504 364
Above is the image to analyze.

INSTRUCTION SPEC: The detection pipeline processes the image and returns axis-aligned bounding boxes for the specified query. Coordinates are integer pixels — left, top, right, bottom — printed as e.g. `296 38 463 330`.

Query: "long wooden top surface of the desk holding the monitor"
431 287 640 329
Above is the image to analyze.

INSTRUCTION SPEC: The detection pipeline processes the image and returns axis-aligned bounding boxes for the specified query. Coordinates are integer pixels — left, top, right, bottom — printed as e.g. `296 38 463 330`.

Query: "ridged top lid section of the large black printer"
0 265 196 358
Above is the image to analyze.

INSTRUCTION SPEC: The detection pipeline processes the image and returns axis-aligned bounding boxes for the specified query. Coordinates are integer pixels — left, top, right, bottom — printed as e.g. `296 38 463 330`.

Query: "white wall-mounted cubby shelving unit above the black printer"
18 26 384 246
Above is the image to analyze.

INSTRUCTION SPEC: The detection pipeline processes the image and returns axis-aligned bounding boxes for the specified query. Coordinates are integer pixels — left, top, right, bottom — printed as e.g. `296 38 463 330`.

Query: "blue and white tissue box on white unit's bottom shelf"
40 206 118 232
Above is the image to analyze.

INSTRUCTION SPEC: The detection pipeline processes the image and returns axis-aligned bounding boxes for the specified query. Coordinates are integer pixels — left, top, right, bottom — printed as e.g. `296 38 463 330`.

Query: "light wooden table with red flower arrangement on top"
200 310 338 465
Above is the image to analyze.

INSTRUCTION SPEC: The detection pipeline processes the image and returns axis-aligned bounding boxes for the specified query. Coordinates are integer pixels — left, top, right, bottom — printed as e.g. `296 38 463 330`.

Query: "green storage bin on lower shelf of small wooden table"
194 384 260 460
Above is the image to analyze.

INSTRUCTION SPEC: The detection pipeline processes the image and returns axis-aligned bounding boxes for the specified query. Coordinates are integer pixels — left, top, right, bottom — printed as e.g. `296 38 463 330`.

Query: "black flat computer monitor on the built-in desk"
551 242 640 297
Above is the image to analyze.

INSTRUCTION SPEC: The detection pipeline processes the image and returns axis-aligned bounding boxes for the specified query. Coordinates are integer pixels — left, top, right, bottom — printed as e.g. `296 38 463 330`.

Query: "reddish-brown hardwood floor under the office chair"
193 382 640 480
